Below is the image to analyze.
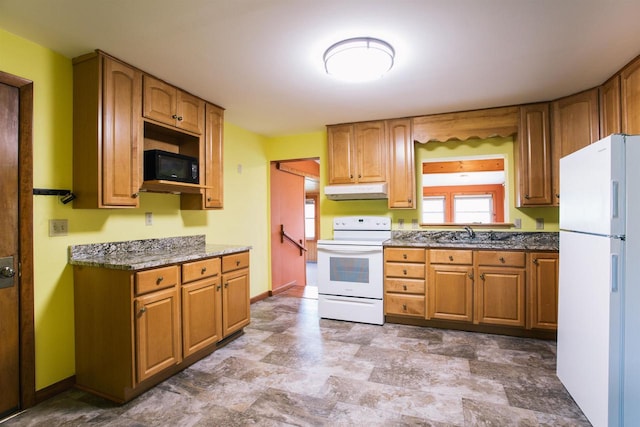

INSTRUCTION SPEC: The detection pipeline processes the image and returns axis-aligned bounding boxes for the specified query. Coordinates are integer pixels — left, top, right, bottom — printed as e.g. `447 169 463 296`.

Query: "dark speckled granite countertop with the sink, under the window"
384 230 559 251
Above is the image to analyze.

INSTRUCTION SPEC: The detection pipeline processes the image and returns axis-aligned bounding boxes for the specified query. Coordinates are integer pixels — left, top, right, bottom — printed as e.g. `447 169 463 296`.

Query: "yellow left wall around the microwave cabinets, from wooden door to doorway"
0 29 269 390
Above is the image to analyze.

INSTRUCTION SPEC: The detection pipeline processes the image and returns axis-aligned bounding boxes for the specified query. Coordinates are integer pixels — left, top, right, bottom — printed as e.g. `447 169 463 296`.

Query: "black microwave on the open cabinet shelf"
144 150 199 184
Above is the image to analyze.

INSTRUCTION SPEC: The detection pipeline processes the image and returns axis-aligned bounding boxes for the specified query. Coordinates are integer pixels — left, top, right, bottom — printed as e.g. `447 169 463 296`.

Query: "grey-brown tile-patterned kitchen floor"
6 295 590 427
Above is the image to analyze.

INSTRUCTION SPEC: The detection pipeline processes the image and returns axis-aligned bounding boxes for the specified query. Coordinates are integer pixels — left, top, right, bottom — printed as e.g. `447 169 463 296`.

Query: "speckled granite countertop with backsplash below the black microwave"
69 235 251 270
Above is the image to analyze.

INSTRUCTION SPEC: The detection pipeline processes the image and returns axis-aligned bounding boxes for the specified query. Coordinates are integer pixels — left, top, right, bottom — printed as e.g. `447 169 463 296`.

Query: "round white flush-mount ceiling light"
323 37 396 81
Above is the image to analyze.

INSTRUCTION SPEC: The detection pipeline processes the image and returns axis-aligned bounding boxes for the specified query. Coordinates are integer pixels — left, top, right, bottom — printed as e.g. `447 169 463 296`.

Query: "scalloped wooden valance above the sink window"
412 106 520 144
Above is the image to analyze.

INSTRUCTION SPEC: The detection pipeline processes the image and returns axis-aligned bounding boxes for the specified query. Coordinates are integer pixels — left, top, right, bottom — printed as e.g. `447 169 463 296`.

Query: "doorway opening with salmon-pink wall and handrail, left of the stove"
270 158 320 298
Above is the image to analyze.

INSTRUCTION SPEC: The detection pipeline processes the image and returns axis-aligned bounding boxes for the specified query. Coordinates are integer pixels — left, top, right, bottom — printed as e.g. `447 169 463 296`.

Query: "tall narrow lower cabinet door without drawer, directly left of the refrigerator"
528 252 559 330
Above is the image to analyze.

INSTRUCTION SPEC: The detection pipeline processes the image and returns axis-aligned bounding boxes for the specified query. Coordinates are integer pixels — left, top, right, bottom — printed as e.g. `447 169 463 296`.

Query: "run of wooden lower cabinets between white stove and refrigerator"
384 247 558 336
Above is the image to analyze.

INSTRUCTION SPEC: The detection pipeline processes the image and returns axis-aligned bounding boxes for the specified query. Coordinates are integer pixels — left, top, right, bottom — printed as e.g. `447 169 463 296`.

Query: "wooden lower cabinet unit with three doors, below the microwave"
74 252 250 403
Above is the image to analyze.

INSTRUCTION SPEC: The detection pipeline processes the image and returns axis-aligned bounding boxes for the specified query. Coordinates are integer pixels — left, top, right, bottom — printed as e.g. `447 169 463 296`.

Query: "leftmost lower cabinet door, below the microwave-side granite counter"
135 287 182 382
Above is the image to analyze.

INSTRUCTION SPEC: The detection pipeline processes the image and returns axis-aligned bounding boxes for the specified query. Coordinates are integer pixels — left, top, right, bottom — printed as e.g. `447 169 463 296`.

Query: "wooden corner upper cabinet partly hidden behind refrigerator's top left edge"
551 88 600 205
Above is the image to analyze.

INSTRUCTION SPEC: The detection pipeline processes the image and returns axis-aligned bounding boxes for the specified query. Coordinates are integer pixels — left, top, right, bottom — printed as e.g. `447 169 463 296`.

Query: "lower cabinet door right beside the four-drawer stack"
427 265 473 322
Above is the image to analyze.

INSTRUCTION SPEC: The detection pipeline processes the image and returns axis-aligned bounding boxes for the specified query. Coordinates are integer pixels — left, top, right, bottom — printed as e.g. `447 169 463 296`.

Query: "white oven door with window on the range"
318 241 383 299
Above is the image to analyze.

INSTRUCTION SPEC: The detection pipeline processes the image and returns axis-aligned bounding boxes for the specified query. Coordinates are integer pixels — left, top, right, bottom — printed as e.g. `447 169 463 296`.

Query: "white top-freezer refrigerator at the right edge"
557 134 640 427
